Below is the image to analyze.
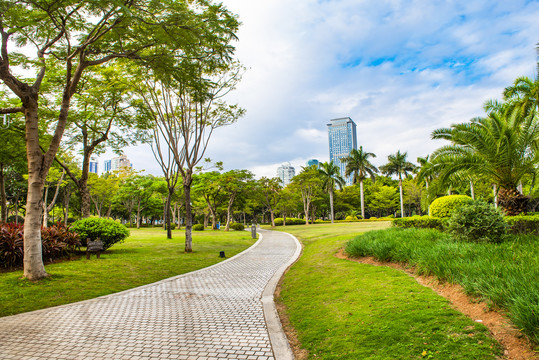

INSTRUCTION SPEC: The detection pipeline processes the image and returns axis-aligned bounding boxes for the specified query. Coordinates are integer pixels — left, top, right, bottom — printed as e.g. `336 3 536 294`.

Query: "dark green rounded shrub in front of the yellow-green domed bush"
447 200 507 243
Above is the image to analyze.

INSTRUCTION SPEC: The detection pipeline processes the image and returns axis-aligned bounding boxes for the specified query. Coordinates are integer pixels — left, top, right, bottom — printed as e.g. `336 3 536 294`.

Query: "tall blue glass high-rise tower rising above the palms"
327 117 357 185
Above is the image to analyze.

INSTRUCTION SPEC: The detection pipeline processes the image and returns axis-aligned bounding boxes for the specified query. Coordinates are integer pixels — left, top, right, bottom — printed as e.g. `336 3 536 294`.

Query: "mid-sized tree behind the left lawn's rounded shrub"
56 64 142 218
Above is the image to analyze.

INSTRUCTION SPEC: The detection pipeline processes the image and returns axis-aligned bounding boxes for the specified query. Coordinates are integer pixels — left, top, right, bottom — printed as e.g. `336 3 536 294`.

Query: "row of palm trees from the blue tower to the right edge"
319 64 539 221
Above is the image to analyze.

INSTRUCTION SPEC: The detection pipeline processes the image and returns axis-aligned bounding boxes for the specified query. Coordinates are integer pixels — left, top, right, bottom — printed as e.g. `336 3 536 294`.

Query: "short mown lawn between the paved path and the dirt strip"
277 223 501 360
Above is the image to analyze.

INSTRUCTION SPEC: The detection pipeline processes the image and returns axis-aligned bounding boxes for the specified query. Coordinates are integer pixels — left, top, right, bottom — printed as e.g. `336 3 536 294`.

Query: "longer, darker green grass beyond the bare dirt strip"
346 229 539 344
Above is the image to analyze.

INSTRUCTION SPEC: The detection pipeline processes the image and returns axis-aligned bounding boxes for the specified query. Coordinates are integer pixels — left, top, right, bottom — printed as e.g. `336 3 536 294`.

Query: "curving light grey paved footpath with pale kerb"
0 230 301 360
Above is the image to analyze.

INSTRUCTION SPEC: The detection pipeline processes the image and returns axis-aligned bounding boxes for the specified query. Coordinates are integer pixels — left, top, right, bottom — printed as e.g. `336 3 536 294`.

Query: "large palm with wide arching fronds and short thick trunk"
432 102 539 215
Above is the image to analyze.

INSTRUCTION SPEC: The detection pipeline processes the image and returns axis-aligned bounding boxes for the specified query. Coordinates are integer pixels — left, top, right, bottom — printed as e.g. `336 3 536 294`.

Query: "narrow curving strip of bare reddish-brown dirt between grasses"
336 249 539 360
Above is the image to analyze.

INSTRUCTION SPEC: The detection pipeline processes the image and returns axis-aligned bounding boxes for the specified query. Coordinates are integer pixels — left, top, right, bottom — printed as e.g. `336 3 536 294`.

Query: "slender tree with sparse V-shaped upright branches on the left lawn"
133 59 245 252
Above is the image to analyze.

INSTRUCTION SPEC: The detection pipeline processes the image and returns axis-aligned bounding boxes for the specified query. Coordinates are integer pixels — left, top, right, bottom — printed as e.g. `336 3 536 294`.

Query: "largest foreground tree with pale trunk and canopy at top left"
0 0 237 280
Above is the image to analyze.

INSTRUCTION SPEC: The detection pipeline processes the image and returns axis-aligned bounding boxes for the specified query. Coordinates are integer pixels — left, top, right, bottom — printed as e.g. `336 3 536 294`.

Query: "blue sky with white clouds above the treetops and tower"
104 0 539 177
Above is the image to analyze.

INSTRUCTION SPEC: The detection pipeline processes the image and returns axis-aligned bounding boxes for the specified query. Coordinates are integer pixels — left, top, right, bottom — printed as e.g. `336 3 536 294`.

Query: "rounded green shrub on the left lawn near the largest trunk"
71 217 129 250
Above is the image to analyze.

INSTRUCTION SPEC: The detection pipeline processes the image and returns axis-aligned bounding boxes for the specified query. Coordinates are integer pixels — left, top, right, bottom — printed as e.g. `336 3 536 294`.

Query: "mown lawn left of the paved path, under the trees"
0 228 254 316
